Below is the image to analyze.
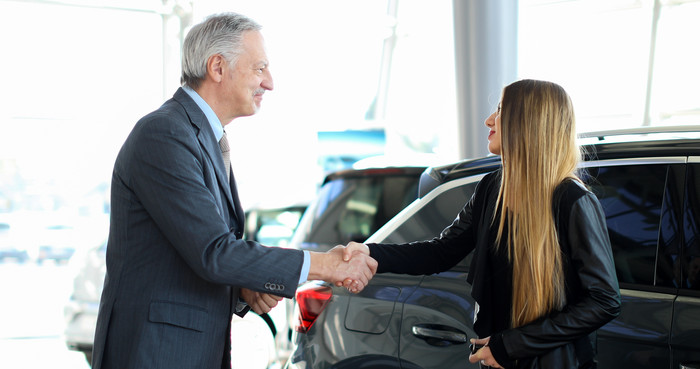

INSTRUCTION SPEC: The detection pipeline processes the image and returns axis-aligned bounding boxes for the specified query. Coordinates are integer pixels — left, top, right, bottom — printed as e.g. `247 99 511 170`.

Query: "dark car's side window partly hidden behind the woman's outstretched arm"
382 182 477 270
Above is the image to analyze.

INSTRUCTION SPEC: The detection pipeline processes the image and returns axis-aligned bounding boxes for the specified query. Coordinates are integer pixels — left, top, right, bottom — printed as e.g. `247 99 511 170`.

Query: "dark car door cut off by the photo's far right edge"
671 157 700 369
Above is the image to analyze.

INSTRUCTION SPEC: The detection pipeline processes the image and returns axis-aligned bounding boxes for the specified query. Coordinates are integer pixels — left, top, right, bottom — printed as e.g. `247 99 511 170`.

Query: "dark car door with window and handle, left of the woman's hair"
374 176 482 369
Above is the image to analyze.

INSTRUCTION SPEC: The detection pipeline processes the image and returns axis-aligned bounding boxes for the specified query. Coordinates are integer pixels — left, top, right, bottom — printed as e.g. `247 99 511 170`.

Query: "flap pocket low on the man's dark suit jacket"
148 301 207 332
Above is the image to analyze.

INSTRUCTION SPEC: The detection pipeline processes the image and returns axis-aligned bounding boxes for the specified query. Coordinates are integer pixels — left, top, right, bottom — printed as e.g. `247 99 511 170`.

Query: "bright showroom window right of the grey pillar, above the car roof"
518 0 700 131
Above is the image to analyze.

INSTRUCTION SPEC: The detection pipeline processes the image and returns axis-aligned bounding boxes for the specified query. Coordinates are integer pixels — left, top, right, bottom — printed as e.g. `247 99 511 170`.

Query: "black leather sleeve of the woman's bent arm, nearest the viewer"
489 192 621 363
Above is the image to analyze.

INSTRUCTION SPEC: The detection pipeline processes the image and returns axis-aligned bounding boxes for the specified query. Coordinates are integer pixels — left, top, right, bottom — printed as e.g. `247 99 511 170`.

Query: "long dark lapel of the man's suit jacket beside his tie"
173 88 245 227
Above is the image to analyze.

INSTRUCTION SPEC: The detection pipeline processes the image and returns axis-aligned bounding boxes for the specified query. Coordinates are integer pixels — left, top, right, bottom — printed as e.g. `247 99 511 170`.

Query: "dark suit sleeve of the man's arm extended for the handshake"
115 113 303 297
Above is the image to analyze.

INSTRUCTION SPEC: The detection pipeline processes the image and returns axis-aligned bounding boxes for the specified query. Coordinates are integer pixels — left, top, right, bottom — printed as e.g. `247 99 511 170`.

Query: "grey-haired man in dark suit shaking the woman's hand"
93 13 376 369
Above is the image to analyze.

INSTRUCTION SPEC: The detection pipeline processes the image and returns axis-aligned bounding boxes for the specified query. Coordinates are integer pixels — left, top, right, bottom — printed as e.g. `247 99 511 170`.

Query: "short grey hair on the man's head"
180 13 262 89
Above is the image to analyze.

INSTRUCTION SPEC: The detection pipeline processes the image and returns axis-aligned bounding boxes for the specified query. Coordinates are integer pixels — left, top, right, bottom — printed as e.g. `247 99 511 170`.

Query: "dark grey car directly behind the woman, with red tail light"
286 126 700 369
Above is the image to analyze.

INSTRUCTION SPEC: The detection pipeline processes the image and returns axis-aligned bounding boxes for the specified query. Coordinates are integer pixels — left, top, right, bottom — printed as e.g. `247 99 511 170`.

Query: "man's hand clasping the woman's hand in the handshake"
309 246 377 293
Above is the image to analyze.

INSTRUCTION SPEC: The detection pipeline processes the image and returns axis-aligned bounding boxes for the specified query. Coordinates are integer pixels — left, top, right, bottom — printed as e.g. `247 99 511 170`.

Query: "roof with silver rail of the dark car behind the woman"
418 126 700 198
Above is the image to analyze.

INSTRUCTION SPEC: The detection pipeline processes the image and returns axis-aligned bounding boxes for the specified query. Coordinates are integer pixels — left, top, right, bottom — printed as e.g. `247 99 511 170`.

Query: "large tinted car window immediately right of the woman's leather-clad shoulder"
586 164 672 286
